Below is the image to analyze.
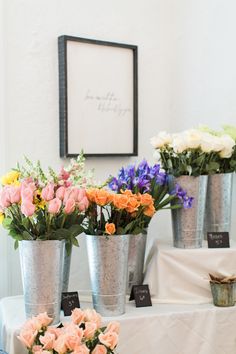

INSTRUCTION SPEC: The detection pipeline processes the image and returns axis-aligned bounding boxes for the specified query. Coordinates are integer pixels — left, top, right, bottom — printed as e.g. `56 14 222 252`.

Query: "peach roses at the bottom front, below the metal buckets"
18 308 120 354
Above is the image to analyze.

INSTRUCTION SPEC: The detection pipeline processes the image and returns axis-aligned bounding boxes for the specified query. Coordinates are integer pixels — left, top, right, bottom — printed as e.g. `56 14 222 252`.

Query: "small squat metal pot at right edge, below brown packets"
210 282 235 307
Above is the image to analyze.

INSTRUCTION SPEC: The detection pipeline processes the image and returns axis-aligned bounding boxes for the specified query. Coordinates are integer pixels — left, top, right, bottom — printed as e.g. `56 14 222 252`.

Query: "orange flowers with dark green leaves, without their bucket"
84 188 155 235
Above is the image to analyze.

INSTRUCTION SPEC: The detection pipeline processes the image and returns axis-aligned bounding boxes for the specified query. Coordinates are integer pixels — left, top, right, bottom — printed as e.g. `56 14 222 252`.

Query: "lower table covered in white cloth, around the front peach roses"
0 296 236 354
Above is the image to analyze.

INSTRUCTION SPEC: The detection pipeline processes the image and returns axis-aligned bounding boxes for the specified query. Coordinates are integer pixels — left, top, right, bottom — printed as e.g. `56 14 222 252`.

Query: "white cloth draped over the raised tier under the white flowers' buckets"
144 240 236 304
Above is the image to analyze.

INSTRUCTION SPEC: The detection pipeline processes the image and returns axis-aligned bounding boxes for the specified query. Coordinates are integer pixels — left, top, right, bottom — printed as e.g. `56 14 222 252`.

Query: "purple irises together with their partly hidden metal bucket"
108 160 192 294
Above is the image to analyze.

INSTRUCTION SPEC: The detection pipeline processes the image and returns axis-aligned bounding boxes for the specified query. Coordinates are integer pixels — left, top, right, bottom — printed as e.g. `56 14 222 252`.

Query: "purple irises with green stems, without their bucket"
108 159 193 227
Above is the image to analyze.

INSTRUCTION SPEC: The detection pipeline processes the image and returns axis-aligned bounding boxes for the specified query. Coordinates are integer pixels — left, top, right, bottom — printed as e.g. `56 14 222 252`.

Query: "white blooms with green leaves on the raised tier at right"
151 129 236 177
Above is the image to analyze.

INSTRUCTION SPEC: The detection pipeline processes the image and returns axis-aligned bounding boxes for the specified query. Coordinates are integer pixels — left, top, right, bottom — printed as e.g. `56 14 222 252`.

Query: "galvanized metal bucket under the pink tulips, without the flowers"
19 240 65 324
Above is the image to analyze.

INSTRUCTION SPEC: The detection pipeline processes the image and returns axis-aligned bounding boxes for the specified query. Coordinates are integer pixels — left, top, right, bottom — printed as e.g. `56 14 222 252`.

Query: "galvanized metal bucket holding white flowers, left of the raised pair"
169 176 208 248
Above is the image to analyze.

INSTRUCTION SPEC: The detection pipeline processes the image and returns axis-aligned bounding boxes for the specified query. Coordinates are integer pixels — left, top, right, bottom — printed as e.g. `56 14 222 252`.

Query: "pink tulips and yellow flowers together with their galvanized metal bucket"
0 160 91 323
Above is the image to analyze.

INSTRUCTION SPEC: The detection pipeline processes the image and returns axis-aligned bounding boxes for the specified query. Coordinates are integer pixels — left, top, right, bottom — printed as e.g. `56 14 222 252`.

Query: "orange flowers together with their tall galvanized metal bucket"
84 188 155 316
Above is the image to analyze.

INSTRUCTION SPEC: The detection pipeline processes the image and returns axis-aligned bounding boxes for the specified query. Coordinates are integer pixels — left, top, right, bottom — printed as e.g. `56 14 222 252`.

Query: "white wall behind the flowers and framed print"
0 0 236 296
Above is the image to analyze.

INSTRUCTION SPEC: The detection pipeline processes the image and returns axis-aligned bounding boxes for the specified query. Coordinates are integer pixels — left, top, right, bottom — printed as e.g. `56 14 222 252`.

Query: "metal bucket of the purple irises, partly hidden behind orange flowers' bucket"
127 233 147 295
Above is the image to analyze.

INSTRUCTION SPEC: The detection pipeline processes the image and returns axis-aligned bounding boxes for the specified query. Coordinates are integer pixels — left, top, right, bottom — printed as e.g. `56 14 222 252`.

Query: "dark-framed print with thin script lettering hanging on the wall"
58 36 138 157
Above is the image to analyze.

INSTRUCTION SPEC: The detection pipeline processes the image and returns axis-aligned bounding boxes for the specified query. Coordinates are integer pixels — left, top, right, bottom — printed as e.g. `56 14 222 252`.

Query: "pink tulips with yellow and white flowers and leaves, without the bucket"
0 157 89 249
